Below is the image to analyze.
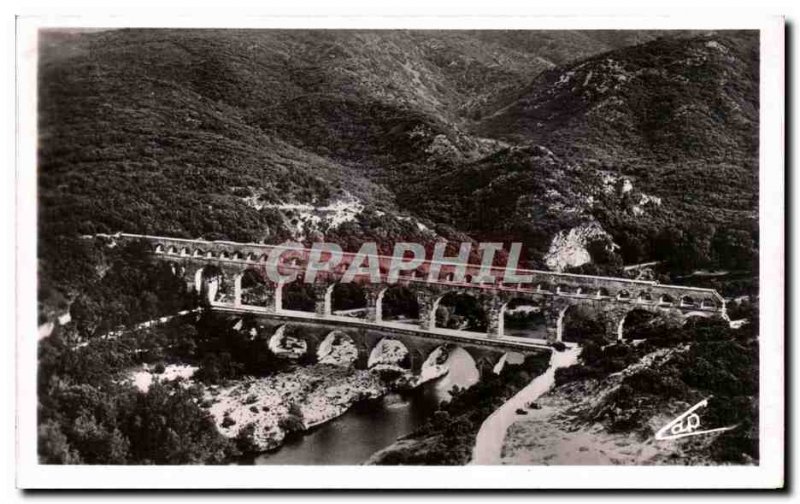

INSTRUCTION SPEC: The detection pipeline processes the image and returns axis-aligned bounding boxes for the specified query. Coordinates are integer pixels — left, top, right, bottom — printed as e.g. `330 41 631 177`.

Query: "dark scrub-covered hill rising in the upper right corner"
477 32 758 238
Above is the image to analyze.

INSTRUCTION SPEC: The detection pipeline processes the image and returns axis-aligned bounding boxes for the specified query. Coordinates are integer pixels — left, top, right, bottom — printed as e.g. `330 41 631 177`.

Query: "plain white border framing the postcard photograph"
16 13 784 489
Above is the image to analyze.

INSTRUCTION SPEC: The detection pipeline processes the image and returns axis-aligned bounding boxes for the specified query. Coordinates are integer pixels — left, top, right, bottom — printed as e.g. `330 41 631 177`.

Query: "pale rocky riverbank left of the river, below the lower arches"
125 334 448 453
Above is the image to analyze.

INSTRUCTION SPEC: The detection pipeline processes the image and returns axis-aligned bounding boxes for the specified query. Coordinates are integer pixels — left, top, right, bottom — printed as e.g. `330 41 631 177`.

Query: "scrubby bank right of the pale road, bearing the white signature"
498 321 758 465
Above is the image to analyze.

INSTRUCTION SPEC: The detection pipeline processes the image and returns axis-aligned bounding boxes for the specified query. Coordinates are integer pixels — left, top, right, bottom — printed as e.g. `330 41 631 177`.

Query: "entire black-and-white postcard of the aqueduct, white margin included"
17 12 784 492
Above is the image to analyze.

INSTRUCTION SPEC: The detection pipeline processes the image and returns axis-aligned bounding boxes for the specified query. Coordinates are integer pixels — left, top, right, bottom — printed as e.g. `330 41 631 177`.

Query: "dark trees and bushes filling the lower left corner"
38 302 310 464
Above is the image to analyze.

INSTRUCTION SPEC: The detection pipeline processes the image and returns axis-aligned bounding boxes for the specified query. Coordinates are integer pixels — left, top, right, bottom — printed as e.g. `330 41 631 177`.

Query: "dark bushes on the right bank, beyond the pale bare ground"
556 319 759 463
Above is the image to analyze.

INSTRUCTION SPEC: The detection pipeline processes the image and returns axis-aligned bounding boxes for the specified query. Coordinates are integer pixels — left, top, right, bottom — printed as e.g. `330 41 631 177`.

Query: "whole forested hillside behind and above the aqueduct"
39 30 758 318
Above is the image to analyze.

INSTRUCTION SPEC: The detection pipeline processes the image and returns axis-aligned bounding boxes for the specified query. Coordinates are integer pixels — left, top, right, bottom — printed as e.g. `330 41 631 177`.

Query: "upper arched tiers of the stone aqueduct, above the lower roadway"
97 233 727 343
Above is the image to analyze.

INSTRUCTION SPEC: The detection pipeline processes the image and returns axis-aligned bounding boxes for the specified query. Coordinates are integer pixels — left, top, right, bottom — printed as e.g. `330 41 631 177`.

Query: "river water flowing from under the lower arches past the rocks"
247 348 479 465
